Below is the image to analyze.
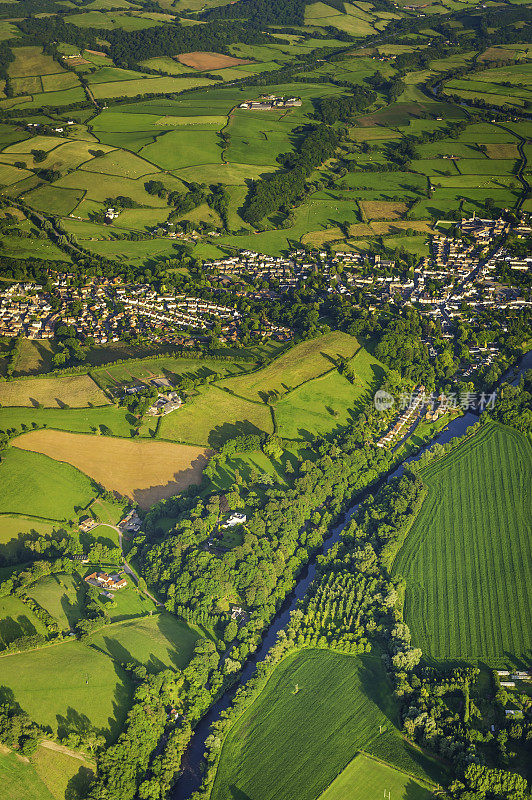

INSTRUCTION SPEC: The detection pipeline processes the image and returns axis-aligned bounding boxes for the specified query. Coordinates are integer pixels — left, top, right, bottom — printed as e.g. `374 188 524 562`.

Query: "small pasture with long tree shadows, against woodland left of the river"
90 612 198 670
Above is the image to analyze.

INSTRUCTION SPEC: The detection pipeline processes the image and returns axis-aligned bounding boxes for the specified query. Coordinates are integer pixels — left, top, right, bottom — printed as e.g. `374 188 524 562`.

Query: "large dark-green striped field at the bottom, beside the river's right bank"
211 649 440 800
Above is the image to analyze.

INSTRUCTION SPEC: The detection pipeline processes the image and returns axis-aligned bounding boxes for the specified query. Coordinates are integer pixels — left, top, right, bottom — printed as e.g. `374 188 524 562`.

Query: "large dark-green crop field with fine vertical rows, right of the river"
393 423 532 665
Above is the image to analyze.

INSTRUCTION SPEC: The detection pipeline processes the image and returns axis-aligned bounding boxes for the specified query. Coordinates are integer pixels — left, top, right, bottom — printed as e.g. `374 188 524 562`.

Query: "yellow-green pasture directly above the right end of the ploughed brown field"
158 386 273 447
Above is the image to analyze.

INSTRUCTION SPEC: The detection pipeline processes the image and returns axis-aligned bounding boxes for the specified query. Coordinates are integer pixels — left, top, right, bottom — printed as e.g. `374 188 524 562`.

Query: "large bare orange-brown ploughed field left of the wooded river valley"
11 429 209 508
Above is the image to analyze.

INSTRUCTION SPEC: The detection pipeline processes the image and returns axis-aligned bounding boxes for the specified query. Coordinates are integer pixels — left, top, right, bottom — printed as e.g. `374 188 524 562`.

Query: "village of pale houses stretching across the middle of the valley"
0 214 532 364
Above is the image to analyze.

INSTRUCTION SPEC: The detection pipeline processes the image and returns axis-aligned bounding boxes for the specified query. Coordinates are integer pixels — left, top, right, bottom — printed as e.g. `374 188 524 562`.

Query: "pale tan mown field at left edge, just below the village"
0 375 109 408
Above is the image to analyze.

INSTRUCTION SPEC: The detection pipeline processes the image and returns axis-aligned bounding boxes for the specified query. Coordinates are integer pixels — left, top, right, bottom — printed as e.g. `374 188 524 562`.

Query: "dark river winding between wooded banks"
172 351 532 800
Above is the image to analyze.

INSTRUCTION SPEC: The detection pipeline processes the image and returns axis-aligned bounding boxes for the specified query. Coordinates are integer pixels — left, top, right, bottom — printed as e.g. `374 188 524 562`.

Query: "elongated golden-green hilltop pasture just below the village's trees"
220 331 360 402
